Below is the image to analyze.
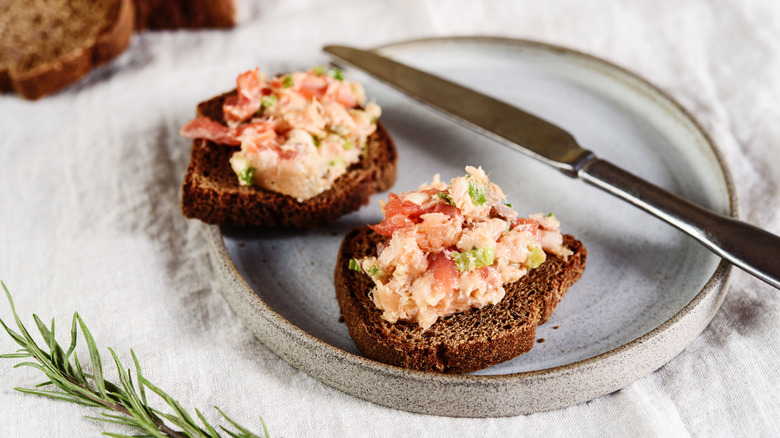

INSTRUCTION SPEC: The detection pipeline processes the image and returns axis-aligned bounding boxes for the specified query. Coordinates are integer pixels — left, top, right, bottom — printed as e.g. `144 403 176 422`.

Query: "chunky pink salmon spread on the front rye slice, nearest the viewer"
350 166 571 329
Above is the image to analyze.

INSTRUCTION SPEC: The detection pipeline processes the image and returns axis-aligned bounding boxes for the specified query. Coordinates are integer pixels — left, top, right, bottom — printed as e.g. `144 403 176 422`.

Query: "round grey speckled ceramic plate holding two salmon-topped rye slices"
208 37 736 417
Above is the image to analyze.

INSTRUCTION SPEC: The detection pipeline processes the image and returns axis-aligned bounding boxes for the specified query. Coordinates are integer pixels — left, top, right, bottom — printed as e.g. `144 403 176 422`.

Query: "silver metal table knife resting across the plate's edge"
324 46 780 289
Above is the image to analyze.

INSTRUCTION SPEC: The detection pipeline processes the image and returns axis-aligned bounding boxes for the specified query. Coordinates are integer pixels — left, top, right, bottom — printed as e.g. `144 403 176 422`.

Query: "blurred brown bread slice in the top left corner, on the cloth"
0 0 133 99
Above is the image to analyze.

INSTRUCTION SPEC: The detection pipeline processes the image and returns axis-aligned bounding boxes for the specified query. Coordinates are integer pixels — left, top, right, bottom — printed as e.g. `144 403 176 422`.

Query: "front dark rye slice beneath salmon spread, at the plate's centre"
334 226 587 373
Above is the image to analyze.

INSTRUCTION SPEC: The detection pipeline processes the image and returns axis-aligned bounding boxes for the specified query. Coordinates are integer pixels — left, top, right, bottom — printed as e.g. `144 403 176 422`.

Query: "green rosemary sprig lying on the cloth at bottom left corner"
0 281 269 438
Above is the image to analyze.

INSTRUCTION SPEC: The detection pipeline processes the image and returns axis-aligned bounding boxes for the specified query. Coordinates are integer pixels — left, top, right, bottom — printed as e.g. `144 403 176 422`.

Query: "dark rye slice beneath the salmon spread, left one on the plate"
182 90 397 228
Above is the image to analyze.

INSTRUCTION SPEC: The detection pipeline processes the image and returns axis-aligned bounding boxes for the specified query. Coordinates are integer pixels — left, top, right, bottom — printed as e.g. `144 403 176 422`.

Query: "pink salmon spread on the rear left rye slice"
180 67 381 202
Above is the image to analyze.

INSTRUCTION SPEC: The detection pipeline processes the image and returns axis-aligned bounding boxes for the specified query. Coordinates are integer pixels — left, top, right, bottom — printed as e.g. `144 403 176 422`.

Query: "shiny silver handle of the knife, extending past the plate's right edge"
578 158 780 289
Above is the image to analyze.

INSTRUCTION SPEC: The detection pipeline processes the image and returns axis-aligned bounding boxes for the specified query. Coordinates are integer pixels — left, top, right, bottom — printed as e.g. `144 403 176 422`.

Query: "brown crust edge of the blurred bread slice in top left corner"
0 0 134 100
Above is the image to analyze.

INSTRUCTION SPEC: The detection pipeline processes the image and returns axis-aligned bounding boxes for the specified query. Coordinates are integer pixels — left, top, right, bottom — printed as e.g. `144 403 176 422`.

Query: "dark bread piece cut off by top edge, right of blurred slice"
134 0 236 30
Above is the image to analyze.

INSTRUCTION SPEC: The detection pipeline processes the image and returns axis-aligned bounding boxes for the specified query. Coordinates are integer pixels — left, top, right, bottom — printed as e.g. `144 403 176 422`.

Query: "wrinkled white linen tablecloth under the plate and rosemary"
0 0 780 437
